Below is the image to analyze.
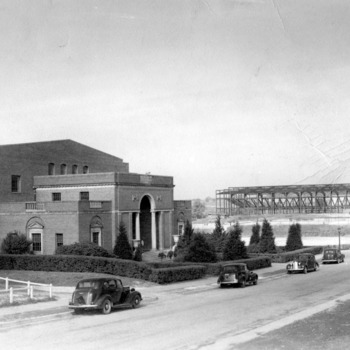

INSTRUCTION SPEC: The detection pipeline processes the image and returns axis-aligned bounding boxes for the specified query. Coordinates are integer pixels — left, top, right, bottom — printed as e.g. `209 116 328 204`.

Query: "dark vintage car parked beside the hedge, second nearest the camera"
217 263 258 288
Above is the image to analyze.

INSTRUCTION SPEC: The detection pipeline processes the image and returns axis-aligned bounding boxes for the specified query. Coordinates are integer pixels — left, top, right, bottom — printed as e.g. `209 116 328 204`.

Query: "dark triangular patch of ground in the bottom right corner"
234 301 350 350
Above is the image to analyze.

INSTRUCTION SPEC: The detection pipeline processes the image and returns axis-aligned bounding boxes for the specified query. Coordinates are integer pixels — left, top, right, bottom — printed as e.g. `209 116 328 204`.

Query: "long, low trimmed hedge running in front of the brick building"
0 254 271 284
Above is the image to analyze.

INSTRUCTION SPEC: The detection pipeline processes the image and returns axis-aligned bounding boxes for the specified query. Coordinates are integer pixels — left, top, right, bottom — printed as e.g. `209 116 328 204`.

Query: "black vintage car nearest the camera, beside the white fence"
68 277 142 314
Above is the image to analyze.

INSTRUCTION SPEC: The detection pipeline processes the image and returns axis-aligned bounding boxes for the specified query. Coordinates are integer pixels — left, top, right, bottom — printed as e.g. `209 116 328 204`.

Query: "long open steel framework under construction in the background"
216 184 350 216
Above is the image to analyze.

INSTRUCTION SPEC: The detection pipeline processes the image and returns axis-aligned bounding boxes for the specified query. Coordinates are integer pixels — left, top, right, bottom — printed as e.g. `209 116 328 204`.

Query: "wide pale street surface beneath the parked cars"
0 251 350 350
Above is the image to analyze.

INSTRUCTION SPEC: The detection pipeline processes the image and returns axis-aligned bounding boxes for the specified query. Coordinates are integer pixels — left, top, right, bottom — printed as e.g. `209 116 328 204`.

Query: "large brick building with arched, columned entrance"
0 140 191 254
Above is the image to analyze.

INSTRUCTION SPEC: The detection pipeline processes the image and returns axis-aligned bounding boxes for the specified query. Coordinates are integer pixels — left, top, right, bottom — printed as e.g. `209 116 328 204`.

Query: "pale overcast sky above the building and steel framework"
0 0 350 199
